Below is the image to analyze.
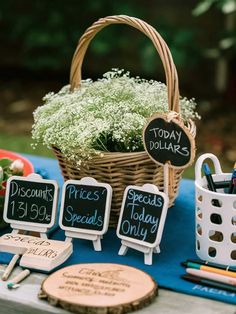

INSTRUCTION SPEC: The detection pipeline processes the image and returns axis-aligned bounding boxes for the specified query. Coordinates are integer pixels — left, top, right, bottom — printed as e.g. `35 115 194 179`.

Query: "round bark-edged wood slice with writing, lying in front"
39 263 158 314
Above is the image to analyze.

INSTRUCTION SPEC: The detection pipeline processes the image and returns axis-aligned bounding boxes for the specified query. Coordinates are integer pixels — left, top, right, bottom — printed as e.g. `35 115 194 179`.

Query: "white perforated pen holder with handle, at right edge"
195 154 236 266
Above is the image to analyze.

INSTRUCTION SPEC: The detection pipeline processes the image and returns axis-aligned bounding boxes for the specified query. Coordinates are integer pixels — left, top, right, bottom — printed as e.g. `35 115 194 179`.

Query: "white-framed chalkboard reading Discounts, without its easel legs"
4 174 58 230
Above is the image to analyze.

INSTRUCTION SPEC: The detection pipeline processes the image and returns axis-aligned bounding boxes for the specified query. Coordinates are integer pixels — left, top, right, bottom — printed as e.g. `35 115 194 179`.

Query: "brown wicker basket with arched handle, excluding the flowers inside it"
53 15 195 226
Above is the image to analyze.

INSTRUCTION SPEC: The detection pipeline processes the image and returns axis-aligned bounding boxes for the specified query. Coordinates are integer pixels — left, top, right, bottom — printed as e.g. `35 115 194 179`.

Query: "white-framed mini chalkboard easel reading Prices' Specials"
59 177 112 251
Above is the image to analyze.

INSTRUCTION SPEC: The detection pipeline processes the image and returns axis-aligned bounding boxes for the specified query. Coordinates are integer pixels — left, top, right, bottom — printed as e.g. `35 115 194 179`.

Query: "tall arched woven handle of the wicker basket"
70 15 179 113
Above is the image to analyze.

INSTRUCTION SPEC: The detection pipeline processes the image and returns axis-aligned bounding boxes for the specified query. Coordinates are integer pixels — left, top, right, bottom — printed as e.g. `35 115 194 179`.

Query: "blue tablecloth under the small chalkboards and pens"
0 155 236 304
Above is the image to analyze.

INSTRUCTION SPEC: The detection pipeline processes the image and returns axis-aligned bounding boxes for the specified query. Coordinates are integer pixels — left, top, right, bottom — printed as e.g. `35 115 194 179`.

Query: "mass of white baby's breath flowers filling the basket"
32 69 199 160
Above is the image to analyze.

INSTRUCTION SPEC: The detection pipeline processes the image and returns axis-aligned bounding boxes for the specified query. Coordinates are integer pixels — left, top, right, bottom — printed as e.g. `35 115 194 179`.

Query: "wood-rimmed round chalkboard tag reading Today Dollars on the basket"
143 115 195 168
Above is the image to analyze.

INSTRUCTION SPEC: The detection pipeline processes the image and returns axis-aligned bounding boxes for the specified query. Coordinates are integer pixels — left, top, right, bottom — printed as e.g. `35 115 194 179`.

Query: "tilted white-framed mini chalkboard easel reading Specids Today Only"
117 184 169 265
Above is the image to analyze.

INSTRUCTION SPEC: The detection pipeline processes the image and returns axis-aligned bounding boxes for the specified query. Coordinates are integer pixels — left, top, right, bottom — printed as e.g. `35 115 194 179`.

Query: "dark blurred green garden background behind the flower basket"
0 0 236 177
